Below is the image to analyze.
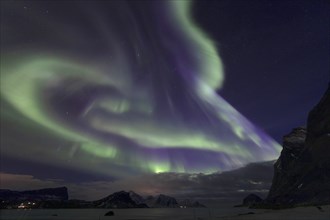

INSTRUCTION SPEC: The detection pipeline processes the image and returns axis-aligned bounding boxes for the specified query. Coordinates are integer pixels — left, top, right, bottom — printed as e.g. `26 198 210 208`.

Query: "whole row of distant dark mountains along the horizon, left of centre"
0 187 205 209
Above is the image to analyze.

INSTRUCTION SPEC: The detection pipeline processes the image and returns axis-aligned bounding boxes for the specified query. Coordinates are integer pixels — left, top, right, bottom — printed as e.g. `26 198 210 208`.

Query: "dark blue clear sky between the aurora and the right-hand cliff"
196 0 330 142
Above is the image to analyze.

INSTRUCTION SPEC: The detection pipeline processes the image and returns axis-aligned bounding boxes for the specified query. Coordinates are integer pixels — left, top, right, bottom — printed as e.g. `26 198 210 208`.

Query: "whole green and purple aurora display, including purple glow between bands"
1 1 328 185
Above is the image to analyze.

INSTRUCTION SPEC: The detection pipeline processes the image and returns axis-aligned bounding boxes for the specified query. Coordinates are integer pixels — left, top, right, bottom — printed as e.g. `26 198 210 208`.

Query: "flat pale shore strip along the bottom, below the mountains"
0 205 330 220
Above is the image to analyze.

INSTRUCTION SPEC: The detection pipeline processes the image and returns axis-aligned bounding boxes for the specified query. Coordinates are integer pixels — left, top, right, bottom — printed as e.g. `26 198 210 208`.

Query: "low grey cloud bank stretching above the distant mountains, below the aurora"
0 161 274 200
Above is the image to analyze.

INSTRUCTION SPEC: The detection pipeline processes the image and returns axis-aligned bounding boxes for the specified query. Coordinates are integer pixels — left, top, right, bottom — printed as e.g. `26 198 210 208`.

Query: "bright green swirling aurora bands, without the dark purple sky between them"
1 1 280 176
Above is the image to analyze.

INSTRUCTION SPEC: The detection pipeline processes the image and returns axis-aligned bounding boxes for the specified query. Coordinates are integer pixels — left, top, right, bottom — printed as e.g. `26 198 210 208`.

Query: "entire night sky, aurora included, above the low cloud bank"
0 0 330 198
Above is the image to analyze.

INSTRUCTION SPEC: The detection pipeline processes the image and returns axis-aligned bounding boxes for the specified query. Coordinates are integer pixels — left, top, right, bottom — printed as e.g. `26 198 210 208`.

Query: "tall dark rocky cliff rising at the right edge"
266 84 330 206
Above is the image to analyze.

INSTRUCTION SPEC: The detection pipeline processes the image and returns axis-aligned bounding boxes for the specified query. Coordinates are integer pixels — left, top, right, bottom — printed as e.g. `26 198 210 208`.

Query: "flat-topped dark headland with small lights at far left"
0 187 69 201
